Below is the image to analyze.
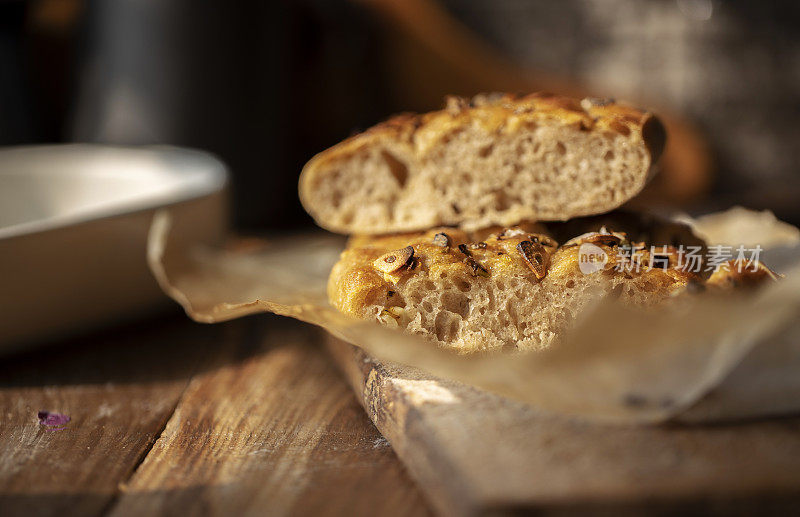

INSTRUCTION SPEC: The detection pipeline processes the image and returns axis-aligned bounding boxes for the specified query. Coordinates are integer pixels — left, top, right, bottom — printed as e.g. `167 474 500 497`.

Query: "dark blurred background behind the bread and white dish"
0 0 800 230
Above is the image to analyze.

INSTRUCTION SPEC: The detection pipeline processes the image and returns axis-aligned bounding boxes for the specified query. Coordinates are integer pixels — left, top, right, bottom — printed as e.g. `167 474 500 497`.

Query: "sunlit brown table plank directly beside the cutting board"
111 315 427 516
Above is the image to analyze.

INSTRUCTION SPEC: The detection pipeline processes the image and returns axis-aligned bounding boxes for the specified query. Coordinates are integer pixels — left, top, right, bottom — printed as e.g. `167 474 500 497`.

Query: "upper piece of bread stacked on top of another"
299 94 665 234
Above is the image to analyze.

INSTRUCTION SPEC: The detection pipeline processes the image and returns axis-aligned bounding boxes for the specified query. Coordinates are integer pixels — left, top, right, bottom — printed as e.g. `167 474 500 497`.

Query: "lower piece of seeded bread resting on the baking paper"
328 216 774 353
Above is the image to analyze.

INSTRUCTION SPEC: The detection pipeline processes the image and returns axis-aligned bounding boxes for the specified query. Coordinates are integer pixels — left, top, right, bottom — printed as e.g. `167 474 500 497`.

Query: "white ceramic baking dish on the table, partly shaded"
0 145 227 352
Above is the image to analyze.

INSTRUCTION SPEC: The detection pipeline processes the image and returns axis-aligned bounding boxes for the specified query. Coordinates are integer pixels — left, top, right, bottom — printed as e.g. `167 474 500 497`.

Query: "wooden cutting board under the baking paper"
328 337 800 515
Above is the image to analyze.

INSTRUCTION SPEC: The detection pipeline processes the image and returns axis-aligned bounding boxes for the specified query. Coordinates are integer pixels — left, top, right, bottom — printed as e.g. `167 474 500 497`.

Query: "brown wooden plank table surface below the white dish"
0 315 430 516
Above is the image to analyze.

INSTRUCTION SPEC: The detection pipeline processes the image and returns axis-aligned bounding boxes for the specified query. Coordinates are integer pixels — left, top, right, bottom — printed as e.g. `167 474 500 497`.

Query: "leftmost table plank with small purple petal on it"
0 317 223 516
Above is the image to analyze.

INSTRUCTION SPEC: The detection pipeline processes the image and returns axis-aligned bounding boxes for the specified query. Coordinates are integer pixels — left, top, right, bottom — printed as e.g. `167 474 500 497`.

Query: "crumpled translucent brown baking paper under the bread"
148 209 800 424
